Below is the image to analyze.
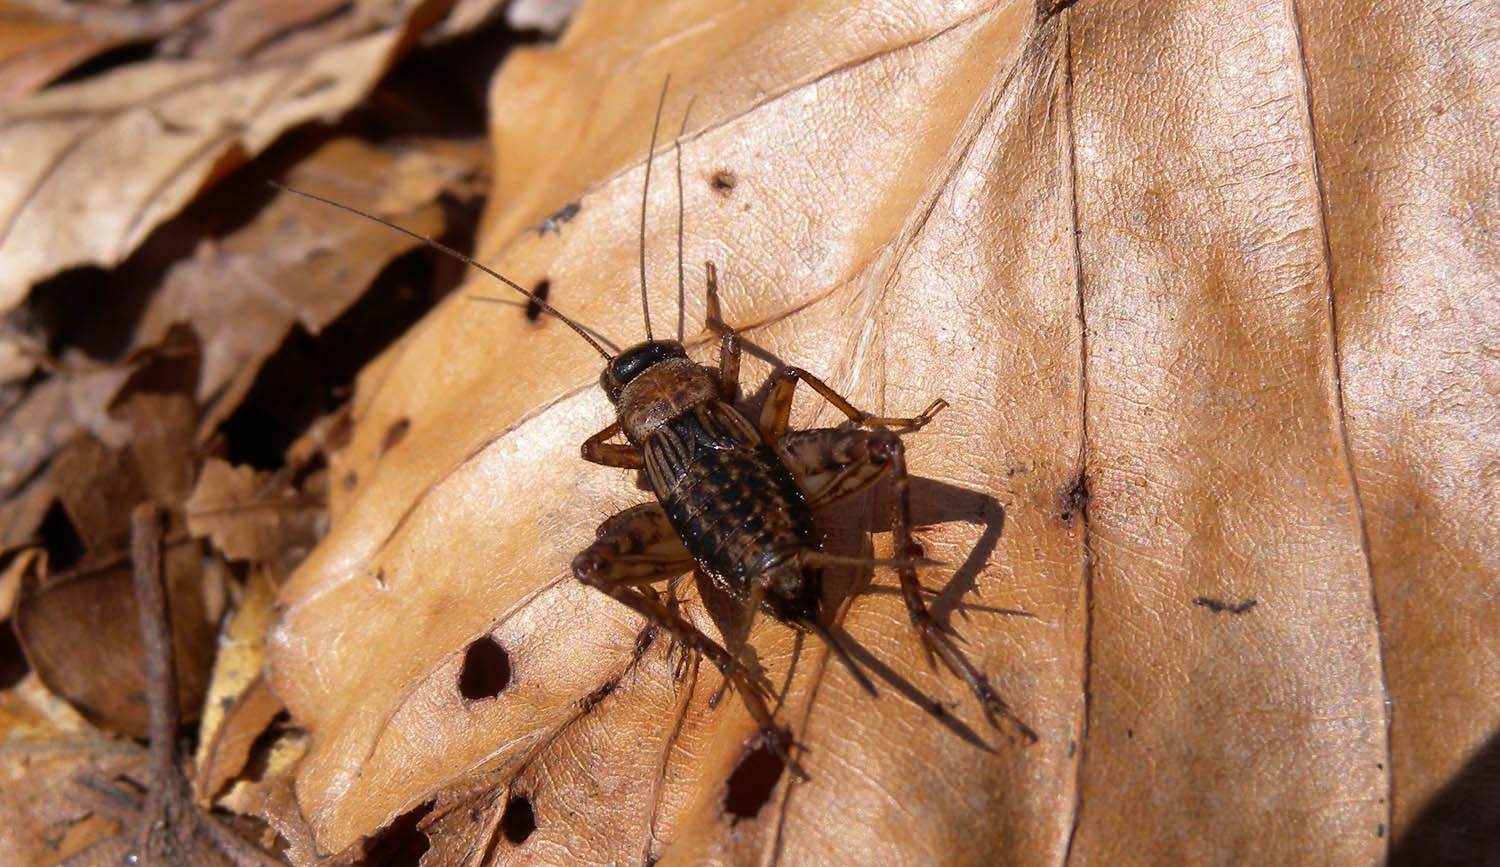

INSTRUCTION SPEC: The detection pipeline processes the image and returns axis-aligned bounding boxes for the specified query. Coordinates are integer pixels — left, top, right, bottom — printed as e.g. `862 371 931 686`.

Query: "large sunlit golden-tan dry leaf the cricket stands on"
270 0 1500 864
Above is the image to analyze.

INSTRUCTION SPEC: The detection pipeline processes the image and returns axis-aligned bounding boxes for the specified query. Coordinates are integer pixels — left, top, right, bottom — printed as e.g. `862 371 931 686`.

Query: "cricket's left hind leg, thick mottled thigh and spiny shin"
573 503 807 780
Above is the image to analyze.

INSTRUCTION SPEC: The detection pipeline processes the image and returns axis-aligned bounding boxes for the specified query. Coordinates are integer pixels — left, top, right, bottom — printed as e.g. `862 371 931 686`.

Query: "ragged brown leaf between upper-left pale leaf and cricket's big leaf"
137 138 483 435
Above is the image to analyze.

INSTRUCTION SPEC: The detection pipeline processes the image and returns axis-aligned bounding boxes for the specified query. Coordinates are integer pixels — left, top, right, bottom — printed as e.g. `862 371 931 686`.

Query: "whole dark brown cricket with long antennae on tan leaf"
270 84 1037 780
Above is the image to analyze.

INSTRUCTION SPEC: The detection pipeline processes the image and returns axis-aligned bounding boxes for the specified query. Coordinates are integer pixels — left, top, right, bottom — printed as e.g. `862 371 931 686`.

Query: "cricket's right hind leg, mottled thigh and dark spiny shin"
777 423 1037 741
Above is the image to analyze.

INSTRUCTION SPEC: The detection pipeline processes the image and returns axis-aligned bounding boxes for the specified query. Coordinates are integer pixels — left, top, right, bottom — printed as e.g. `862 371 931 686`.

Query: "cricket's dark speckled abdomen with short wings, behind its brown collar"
642 401 821 620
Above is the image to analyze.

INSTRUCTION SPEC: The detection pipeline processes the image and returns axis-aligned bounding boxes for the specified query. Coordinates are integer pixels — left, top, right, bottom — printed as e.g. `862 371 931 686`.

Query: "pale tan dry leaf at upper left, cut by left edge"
0 0 447 309
